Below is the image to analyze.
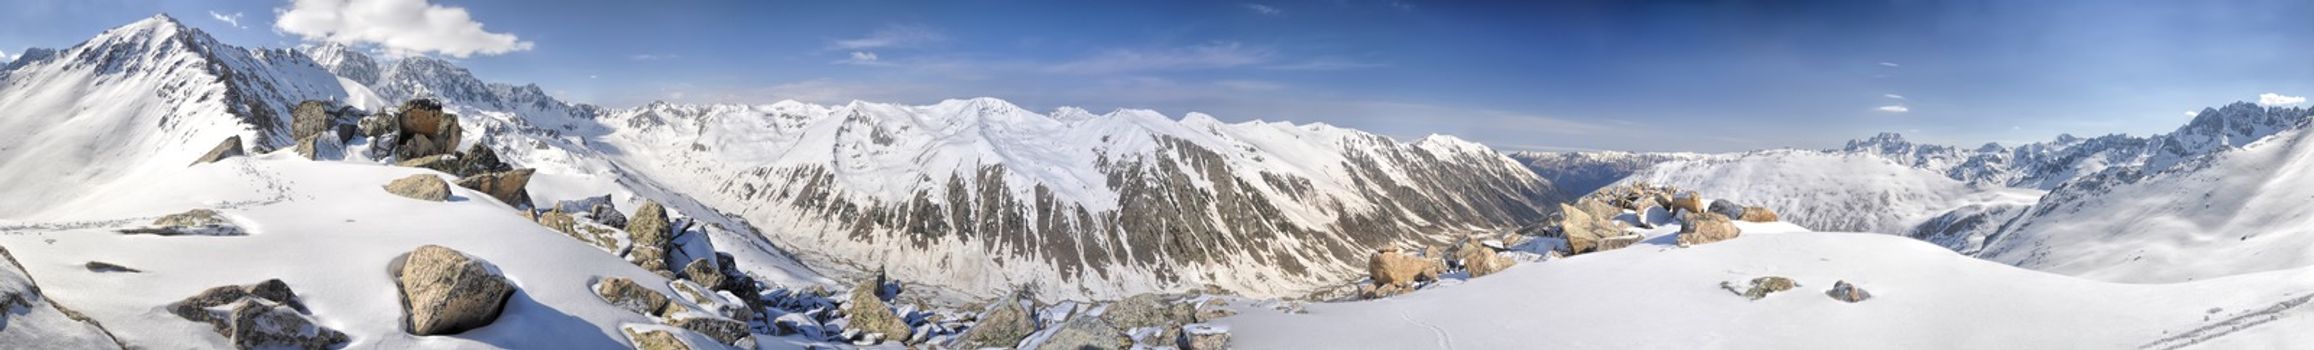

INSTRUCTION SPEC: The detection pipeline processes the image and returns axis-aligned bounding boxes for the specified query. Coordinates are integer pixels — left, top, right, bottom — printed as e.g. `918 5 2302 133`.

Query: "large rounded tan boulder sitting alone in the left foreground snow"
393 246 514 336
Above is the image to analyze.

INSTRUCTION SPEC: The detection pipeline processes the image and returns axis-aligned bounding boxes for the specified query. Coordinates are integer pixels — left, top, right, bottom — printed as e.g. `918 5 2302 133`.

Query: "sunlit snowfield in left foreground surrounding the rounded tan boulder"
0 153 823 348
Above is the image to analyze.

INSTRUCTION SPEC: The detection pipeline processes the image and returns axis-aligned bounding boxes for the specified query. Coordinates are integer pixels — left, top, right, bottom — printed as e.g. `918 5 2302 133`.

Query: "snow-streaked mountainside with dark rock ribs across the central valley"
604 97 1560 299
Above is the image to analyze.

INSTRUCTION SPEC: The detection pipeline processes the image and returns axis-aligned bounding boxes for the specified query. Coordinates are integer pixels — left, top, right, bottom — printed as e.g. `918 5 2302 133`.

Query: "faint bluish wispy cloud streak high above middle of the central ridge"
1046 42 1277 74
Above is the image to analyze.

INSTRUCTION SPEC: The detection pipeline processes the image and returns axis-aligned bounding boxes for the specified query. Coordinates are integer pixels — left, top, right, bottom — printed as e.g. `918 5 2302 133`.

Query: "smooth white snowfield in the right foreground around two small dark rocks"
1222 232 2314 350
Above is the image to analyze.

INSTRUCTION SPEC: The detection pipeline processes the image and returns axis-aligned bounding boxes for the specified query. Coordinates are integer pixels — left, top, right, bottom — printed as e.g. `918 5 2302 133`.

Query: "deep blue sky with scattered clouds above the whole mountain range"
0 0 2314 151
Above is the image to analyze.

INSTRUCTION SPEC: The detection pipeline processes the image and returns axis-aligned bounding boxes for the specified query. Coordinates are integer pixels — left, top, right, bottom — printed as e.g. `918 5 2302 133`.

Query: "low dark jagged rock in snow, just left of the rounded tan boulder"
167 280 347 350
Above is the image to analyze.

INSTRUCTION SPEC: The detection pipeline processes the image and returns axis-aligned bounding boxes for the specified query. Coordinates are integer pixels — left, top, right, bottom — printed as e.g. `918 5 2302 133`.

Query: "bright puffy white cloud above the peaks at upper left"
273 0 532 58
